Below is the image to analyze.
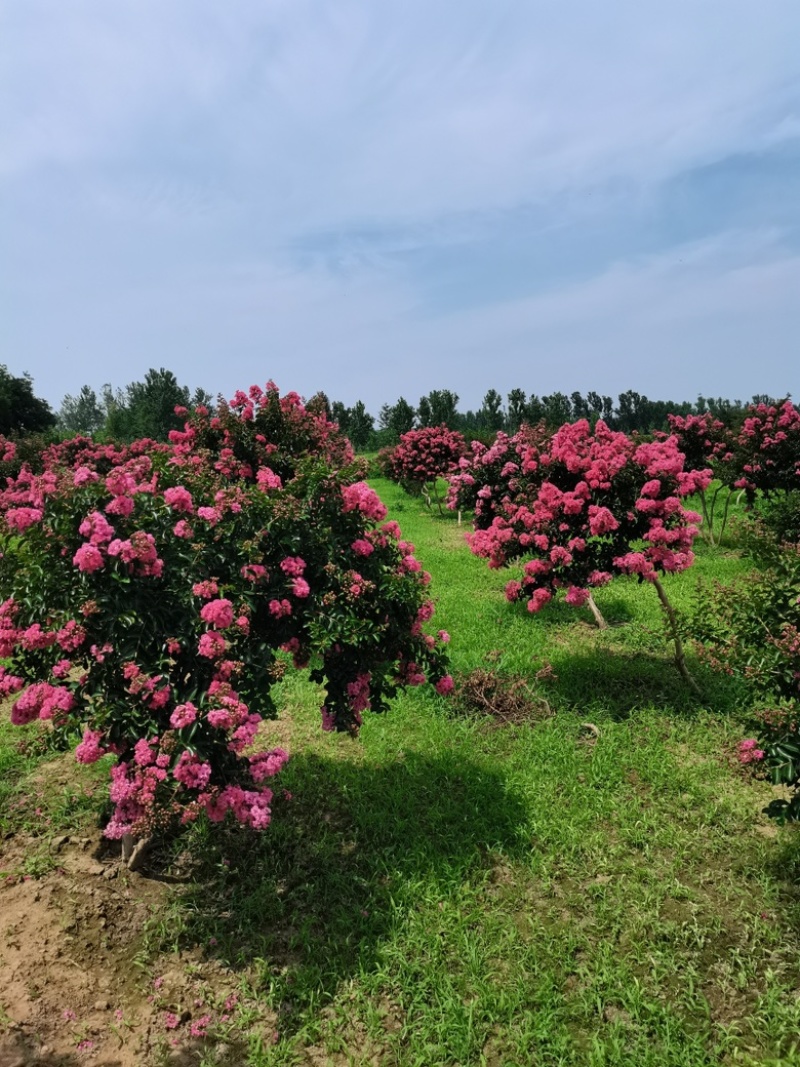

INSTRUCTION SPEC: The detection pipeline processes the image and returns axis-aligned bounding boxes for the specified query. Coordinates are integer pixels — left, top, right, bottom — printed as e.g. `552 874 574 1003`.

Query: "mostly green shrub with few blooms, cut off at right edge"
692 522 800 819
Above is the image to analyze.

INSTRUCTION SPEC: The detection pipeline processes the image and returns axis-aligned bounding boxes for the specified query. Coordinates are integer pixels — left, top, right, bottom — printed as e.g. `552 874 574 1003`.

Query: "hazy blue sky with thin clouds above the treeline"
0 0 800 415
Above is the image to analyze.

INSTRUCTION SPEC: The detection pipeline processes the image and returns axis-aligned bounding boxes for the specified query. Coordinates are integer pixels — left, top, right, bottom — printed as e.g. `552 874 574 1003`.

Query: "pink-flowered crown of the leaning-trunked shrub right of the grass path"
450 419 711 611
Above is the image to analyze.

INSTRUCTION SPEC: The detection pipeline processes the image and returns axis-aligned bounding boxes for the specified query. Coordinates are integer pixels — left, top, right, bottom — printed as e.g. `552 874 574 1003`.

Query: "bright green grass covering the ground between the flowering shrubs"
0 481 800 1067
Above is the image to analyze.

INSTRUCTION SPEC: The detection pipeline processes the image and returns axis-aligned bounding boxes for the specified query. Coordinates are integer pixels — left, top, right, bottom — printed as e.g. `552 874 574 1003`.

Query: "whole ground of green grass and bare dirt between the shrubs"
0 479 800 1067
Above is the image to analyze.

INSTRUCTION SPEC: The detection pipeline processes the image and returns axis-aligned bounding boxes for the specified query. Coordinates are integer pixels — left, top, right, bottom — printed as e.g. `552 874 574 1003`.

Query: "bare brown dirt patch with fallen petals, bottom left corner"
0 831 270 1067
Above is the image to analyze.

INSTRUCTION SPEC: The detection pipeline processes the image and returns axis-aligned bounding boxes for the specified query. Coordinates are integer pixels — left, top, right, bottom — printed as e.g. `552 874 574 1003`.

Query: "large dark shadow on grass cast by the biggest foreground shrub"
157 752 533 1028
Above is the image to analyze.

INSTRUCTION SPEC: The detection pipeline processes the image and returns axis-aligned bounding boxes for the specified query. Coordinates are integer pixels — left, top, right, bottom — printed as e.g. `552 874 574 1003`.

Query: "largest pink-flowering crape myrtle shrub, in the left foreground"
0 383 452 840
